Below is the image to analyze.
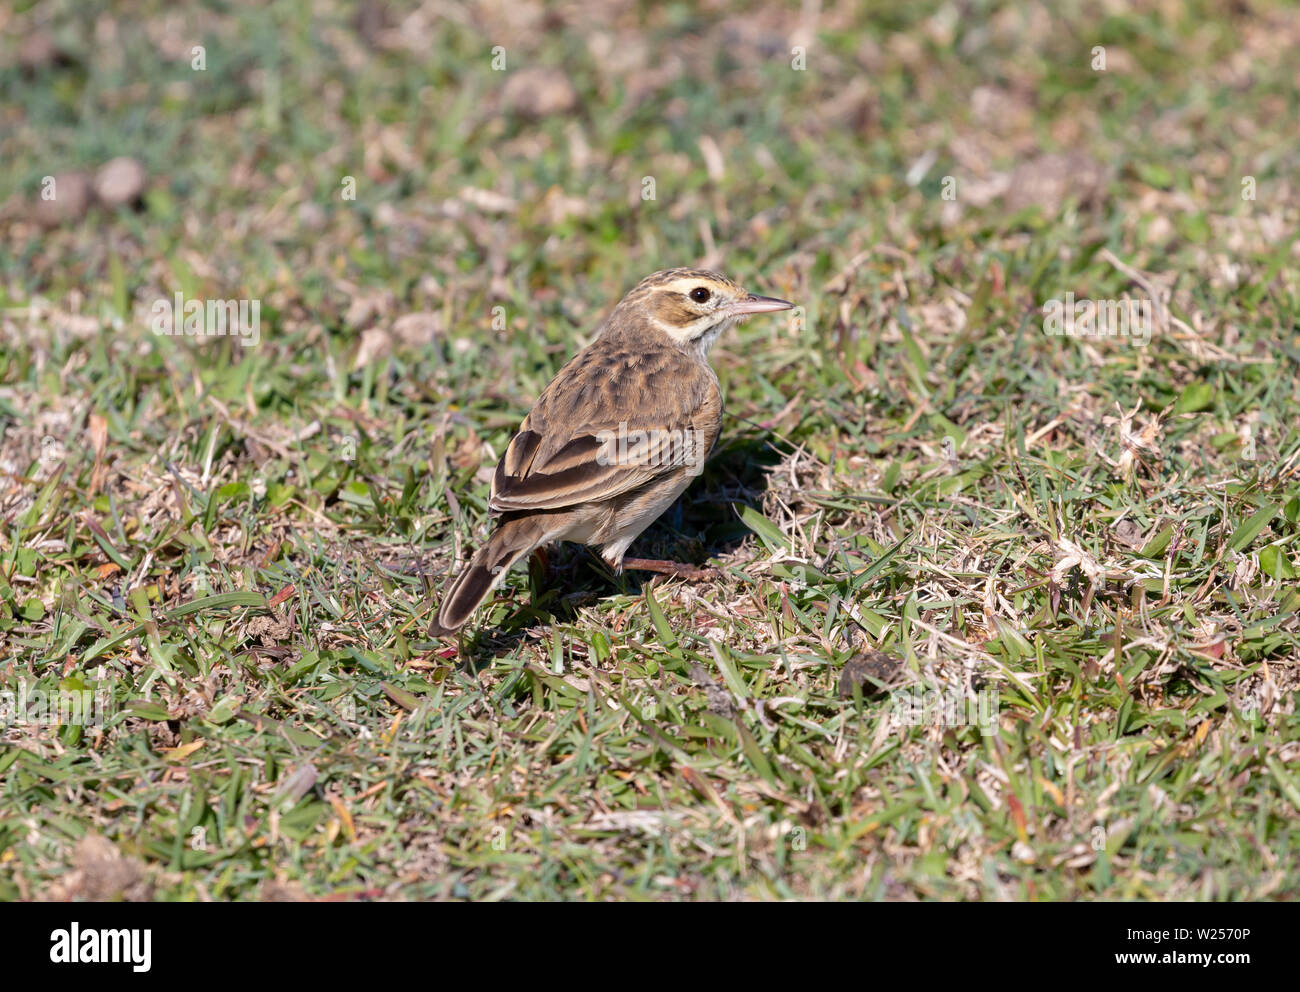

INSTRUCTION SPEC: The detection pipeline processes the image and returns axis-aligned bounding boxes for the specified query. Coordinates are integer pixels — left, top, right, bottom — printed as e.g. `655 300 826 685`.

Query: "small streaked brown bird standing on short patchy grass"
430 268 794 636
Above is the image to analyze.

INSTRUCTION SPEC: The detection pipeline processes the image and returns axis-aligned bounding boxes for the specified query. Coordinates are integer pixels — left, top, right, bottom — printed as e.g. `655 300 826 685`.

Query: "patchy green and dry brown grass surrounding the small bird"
0 0 1300 900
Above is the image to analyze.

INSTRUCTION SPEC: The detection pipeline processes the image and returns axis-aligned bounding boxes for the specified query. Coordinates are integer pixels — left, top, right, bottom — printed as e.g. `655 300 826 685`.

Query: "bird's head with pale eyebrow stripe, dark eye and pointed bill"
615 269 794 354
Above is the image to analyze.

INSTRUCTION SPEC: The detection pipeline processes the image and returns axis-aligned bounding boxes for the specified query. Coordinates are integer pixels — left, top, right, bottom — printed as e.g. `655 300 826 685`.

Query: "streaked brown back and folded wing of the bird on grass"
490 341 722 512
